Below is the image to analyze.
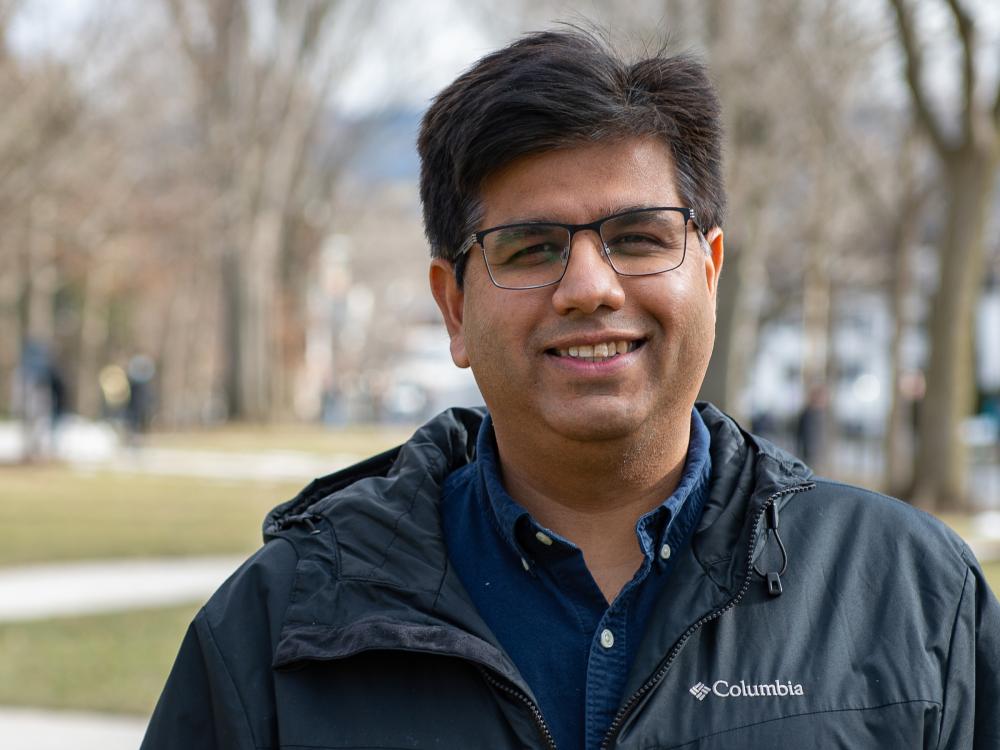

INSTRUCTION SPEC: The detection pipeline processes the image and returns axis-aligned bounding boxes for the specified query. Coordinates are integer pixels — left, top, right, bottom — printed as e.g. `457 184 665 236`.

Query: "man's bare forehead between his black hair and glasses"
480 138 681 227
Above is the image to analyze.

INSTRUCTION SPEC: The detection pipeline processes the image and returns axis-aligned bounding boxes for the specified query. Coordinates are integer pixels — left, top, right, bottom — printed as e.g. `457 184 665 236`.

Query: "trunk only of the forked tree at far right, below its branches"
911 147 997 510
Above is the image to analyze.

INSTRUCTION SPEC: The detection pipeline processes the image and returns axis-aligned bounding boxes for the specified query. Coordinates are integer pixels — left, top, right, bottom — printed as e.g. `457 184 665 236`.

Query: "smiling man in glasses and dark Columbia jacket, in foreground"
144 26 1000 749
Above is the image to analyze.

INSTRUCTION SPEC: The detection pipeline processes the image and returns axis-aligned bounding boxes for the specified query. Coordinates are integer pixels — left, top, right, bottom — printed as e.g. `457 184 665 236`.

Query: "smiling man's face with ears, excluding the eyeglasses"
431 138 722 450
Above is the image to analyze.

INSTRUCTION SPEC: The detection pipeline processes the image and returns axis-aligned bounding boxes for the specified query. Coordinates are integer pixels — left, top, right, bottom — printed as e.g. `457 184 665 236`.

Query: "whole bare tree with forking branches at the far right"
890 0 1000 509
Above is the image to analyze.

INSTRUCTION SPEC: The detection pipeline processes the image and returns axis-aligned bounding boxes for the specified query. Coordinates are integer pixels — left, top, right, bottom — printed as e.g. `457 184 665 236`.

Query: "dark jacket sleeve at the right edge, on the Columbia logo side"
938 550 1000 750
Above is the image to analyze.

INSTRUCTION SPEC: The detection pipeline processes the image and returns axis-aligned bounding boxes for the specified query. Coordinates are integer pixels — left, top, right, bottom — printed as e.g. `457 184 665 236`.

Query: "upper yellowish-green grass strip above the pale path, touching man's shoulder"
0 467 302 566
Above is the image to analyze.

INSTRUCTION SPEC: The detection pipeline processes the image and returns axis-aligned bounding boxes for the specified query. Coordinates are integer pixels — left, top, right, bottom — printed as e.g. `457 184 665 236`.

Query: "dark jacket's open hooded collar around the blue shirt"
264 404 811 694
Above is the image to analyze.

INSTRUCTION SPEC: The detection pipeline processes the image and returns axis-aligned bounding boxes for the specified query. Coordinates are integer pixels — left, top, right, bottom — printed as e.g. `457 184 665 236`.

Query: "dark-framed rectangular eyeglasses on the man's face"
458 206 697 289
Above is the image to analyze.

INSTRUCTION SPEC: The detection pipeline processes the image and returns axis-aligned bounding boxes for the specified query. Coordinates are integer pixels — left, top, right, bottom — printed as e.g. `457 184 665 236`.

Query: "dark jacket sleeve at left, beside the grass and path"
142 539 297 750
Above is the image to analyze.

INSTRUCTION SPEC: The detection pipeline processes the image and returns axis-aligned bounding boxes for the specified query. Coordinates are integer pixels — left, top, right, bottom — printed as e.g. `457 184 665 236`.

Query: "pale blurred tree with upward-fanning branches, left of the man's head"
166 0 376 420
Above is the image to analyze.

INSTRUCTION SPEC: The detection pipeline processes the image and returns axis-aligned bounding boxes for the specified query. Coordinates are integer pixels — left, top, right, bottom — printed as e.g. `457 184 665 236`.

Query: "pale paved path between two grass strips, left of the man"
0 557 244 622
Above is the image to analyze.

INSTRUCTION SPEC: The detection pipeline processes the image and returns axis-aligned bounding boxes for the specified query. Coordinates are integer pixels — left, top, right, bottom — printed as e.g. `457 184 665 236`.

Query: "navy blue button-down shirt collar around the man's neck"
476 409 711 559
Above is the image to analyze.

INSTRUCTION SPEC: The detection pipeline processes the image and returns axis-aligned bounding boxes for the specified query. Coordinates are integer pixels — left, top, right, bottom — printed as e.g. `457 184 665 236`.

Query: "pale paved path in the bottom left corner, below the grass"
0 707 146 750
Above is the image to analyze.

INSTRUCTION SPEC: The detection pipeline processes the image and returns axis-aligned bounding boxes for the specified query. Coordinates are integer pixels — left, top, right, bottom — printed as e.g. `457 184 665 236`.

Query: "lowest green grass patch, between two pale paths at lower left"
0 605 198 715
